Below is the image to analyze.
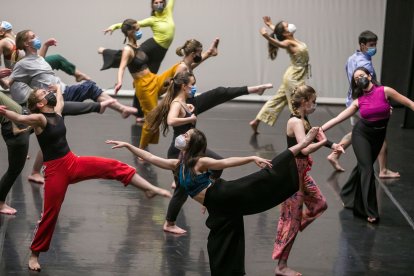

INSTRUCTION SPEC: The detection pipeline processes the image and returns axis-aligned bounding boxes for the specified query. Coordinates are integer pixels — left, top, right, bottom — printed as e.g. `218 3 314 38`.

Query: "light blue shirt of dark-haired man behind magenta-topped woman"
345 50 377 107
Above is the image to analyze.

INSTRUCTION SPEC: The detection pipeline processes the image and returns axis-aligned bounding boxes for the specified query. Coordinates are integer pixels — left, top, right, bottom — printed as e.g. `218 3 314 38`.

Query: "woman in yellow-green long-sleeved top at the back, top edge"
103 0 175 122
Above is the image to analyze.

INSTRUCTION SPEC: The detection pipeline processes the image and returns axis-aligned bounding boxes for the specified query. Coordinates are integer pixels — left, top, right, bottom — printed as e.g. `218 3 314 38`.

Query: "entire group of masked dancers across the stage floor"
0 0 414 275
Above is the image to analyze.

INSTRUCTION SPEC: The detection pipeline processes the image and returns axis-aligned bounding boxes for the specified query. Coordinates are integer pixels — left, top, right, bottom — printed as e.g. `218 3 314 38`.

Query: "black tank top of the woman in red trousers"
37 113 70 161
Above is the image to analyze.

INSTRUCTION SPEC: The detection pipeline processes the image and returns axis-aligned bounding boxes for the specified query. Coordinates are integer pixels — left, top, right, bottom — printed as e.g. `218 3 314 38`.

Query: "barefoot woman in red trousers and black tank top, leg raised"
0 83 171 271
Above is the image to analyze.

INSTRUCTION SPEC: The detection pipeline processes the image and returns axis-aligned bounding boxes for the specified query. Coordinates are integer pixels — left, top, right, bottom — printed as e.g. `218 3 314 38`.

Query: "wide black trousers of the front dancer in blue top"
204 150 299 275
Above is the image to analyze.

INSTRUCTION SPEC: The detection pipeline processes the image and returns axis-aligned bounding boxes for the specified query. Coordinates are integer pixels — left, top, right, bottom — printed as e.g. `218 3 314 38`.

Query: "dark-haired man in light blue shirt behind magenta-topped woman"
327 31 400 178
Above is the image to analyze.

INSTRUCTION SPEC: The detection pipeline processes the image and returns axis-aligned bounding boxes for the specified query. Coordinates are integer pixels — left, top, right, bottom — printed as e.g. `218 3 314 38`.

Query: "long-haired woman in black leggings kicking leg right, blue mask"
147 71 273 234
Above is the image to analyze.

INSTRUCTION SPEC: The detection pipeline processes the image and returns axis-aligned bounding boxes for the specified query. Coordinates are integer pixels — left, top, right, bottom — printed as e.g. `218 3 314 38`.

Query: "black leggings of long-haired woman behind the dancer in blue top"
165 86 248 222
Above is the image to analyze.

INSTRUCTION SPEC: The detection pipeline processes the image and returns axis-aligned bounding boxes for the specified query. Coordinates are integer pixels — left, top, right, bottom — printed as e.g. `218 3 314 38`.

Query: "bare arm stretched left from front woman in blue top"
105 140 179 170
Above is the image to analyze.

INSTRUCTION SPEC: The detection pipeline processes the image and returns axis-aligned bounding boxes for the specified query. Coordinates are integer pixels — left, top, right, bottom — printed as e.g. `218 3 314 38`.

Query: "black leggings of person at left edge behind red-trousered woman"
0 124 30 202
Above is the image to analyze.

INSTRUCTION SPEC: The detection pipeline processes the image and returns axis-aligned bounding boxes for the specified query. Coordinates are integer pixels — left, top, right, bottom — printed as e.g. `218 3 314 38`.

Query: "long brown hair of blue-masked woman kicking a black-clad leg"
146 71 194 136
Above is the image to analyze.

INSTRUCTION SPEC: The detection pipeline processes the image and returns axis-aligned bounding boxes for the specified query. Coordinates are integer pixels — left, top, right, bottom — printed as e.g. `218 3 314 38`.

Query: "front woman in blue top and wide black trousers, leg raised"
107 128 318 276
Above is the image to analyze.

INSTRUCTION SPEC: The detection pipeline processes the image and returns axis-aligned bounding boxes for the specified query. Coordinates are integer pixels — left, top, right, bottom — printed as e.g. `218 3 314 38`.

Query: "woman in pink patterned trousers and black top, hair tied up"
272 85 343 276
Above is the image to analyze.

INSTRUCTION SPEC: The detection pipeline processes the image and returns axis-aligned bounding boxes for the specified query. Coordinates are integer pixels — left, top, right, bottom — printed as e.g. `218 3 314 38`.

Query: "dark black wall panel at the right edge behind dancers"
381 0 414 128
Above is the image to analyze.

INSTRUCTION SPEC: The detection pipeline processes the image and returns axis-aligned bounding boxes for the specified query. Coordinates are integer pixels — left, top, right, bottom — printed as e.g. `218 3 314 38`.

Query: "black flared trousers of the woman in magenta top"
341 119 388 218
